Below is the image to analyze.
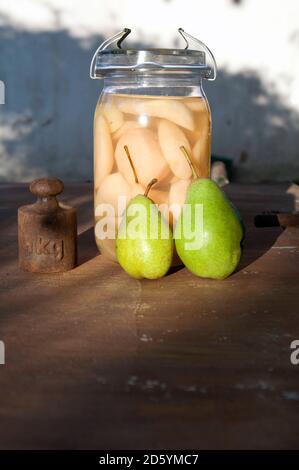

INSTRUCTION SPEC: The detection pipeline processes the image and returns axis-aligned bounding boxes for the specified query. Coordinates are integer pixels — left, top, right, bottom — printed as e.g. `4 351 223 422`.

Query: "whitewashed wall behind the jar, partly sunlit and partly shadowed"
0 0 299 181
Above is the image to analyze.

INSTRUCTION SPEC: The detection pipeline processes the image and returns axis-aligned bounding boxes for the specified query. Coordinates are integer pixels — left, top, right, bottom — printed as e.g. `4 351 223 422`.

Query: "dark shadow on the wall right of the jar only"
205 70 299 182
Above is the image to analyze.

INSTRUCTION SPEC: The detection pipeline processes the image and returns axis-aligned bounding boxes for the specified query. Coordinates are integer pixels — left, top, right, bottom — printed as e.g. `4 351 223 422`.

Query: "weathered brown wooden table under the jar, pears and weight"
0 184 299 449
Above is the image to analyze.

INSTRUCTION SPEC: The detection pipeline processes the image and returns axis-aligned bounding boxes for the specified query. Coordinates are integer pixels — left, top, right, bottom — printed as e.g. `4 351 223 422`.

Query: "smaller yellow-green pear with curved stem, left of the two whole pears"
116 180 174 279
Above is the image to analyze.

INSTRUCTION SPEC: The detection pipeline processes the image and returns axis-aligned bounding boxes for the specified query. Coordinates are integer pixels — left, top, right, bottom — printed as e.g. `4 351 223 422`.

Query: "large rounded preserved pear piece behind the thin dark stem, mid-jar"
115 129 169 186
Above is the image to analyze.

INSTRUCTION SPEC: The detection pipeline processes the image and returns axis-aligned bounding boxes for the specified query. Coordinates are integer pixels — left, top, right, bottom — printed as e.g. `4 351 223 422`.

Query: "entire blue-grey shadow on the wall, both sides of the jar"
0 22 299 181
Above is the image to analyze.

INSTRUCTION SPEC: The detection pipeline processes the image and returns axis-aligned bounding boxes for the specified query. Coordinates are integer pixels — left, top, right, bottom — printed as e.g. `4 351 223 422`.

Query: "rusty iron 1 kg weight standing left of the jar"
18 178 77 273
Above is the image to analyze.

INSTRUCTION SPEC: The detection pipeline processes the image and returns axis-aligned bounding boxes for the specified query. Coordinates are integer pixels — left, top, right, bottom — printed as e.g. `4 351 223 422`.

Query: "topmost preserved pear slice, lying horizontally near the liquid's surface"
118 99 194 131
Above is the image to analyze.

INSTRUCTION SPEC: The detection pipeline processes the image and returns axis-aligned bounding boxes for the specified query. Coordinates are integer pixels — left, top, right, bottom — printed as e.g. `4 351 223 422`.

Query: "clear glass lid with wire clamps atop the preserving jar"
90 28 217 81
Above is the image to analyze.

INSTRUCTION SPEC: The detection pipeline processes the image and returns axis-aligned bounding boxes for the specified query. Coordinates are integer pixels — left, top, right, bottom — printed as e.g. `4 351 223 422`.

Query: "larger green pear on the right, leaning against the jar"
174 179 244 279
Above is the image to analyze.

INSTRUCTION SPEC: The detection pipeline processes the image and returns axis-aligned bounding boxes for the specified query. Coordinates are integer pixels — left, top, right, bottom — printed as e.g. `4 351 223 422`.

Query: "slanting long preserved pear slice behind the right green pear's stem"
158 120 192 179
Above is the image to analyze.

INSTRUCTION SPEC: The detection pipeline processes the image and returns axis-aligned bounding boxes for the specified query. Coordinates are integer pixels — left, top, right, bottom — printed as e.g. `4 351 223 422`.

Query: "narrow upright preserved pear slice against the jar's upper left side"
94 114 113 188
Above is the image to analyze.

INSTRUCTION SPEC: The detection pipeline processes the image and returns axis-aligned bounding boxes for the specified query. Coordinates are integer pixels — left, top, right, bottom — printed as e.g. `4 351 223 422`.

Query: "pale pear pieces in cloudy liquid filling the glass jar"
94 93 211 261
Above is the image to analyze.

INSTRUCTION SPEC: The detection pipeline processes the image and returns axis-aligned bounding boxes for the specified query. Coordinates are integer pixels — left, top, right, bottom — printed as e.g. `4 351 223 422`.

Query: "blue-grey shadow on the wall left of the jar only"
0 18 103 181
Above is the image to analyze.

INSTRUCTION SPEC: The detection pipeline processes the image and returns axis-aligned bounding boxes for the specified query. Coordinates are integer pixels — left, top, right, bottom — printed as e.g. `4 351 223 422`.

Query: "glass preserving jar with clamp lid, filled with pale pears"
90 29 216 261
